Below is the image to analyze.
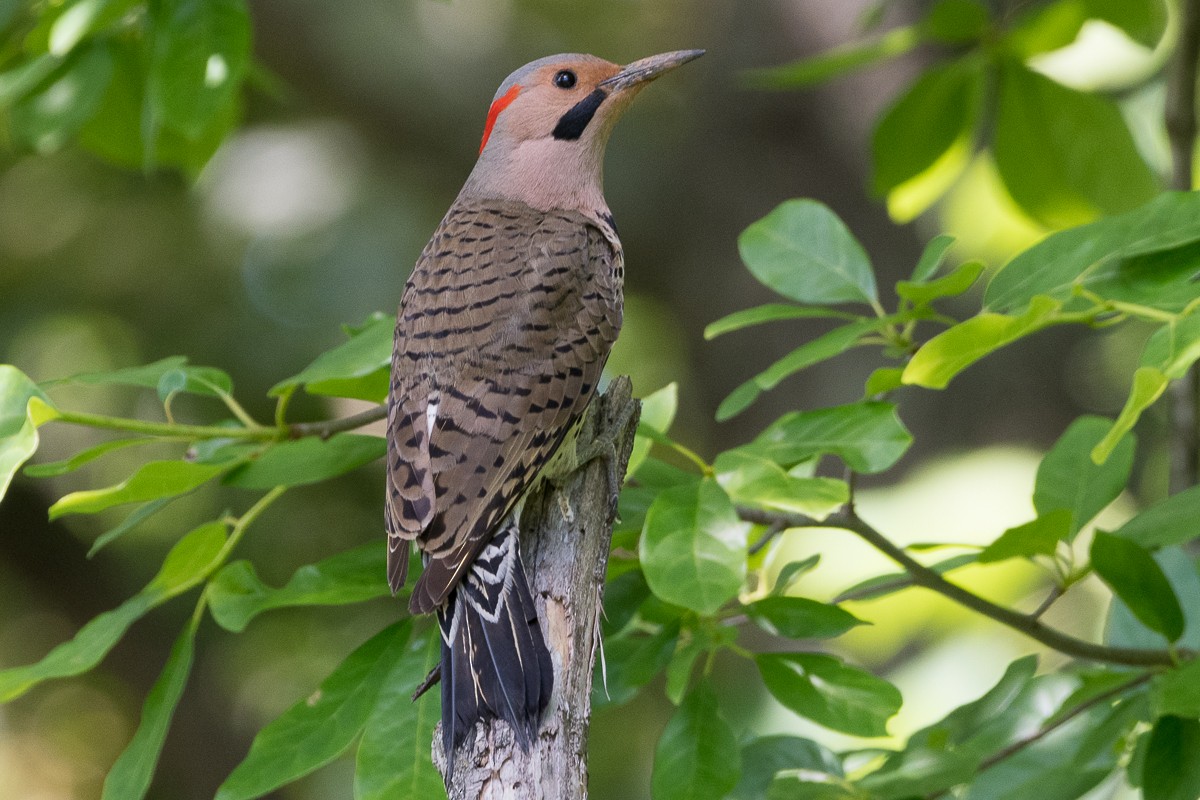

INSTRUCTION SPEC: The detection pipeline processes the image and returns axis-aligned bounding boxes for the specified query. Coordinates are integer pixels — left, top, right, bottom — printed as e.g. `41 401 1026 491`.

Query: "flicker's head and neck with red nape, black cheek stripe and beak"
464 50 704 207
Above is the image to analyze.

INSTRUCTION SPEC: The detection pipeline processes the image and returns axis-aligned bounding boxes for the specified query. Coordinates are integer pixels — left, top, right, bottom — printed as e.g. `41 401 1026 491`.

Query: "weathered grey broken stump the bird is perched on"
433 378 640 800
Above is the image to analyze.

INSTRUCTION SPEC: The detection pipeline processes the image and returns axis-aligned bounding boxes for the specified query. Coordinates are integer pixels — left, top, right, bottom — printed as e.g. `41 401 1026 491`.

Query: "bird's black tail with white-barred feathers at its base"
438 524 554 770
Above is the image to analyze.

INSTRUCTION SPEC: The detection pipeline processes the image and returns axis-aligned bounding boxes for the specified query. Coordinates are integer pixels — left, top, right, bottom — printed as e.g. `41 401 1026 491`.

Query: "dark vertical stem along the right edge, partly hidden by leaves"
1165 0 1200 492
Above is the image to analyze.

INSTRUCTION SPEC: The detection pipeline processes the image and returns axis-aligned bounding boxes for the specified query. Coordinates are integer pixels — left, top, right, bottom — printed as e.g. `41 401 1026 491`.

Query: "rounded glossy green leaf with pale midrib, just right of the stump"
640 477 749 614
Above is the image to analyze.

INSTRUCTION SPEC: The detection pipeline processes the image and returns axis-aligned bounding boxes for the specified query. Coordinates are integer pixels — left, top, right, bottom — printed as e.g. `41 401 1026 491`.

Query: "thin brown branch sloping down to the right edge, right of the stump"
738 506 1195 667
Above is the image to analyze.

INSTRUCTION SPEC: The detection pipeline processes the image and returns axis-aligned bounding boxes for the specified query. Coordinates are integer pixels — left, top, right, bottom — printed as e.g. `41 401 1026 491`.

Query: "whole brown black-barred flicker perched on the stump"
386 50 703 758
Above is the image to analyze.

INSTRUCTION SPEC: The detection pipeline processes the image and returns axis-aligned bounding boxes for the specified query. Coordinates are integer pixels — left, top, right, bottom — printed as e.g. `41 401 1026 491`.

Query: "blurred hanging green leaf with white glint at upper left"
148 0 250 139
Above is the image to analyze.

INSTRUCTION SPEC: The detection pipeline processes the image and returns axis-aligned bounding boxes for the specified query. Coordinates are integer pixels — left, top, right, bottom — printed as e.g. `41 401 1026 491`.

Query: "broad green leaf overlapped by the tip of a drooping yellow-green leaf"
1033 416 1135 539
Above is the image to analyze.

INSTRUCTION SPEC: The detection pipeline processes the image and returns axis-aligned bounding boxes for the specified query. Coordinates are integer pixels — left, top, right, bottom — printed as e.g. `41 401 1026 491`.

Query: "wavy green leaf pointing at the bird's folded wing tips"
209 543 390 633
